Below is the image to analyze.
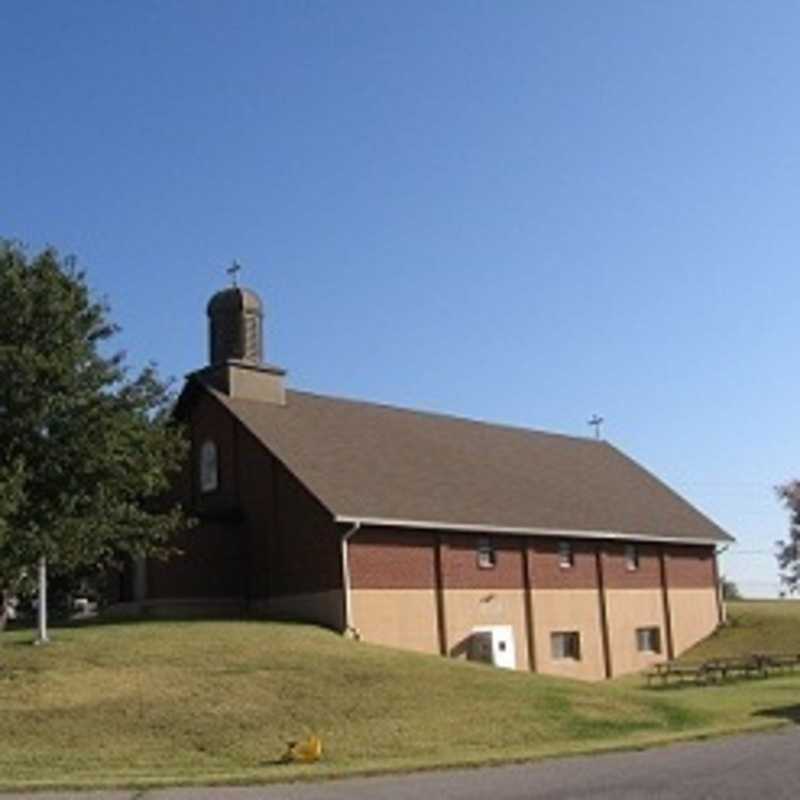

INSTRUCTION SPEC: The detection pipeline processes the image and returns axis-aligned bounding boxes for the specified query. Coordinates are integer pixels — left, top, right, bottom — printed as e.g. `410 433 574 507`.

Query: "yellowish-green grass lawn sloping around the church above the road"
0 603 800 789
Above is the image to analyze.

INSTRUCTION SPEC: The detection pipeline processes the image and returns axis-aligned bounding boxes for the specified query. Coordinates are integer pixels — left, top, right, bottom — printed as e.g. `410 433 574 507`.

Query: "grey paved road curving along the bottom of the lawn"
6 727 800 800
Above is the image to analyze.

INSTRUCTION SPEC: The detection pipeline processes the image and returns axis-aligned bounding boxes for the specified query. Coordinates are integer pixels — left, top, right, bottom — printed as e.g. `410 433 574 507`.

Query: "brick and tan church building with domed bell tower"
126 286 731 680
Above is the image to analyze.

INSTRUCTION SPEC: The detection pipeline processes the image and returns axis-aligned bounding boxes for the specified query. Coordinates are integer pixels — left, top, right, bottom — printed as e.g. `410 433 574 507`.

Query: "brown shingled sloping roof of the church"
205 387 731 543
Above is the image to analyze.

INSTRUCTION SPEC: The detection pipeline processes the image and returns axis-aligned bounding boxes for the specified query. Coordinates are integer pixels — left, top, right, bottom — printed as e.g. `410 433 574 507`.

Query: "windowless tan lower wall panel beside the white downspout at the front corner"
351 589 439 653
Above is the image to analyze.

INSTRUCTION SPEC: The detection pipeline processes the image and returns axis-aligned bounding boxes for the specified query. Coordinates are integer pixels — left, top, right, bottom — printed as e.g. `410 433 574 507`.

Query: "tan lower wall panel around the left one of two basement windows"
531 589 605 680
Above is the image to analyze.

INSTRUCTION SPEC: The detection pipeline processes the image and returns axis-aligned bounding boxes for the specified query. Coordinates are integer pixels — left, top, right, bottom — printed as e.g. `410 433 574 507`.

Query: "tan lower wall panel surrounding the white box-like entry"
444 589 529 670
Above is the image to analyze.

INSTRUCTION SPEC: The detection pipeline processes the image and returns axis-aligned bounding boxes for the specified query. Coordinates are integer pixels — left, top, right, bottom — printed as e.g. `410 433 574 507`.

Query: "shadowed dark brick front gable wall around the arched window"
148 392 342 601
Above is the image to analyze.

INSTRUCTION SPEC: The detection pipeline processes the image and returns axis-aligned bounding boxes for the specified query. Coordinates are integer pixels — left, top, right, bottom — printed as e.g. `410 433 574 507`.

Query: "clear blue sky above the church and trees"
0 0 800 596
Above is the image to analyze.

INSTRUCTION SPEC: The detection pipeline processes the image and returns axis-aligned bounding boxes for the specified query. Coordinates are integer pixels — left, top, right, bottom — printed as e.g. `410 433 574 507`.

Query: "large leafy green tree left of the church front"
0 242 187 636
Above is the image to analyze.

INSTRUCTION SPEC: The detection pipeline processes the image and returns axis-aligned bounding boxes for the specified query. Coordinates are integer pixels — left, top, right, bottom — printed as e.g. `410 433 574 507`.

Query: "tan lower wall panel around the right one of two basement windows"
606 588 667 676
